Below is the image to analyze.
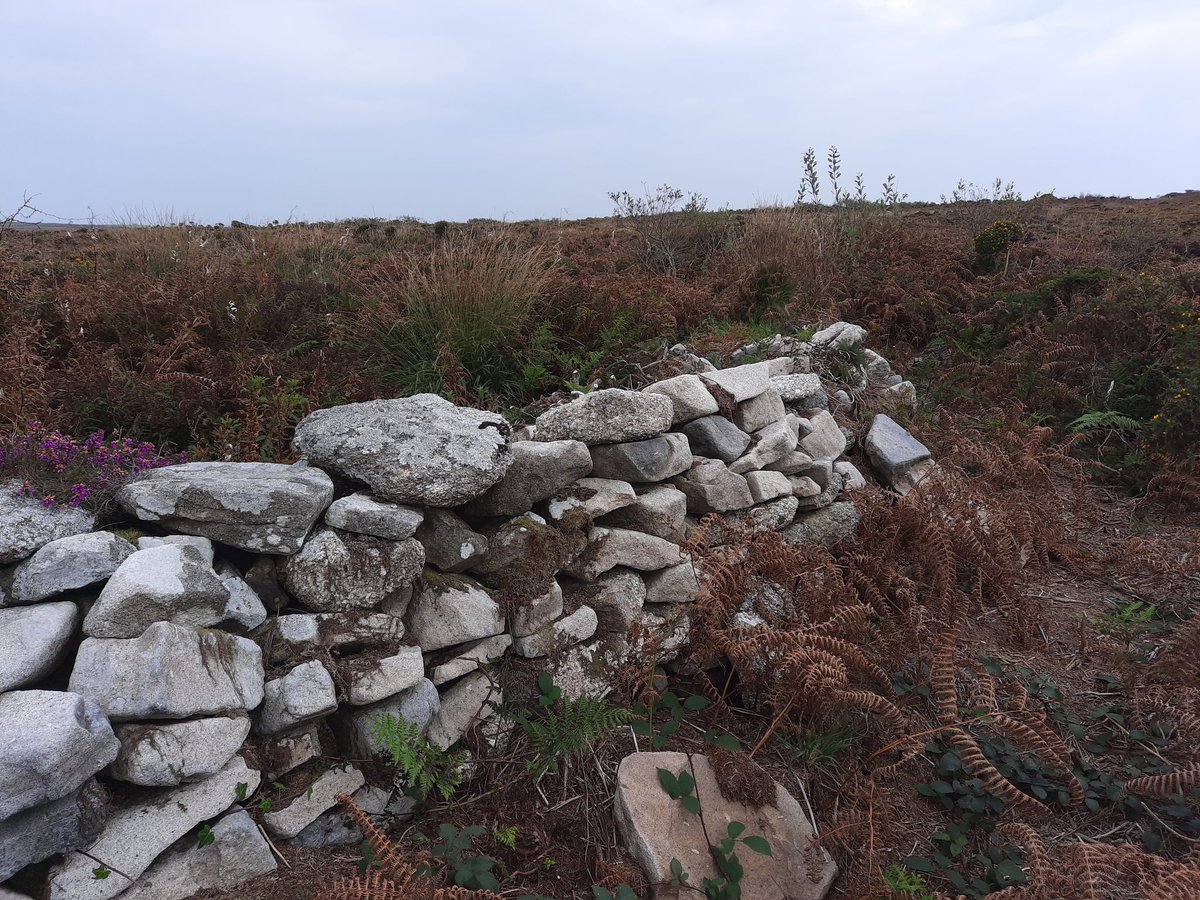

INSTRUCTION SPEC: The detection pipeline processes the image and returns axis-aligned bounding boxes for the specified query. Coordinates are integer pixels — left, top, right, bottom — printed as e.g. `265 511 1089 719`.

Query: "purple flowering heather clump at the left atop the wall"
0 421 187 511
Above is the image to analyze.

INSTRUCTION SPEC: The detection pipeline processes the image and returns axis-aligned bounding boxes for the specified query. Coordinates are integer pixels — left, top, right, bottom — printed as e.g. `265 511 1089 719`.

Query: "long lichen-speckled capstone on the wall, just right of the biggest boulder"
536 388 674 444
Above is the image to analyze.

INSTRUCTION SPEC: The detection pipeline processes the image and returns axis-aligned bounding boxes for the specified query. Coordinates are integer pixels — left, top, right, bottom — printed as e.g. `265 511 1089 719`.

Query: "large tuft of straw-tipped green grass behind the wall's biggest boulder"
361 235 553 398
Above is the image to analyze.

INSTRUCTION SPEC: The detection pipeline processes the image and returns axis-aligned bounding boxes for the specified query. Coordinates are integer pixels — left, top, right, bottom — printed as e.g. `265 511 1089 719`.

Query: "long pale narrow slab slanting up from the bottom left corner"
46 756 259 900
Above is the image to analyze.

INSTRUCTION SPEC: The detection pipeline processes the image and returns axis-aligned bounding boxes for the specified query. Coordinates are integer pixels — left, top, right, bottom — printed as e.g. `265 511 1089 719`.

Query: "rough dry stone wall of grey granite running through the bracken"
0 323 932 900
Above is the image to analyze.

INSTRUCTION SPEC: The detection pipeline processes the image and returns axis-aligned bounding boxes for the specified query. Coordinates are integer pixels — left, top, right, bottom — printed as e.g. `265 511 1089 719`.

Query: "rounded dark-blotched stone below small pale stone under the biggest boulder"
280 528 425 612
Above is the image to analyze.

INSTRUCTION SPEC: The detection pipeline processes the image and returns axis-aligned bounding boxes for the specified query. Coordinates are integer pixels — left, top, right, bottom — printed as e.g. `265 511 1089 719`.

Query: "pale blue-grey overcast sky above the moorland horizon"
0 0 1200 223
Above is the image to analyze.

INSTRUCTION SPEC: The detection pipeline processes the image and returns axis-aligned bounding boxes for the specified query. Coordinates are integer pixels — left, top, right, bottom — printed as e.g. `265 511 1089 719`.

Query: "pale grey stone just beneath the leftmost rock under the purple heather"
11 532 133 605
